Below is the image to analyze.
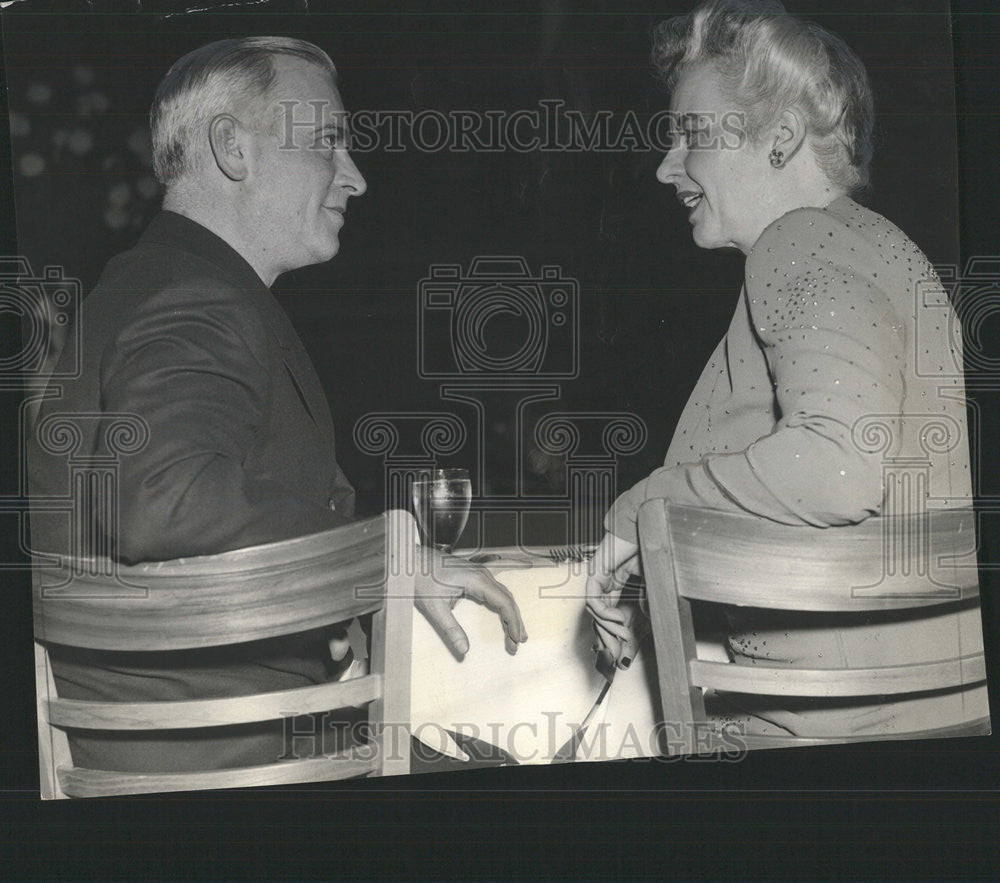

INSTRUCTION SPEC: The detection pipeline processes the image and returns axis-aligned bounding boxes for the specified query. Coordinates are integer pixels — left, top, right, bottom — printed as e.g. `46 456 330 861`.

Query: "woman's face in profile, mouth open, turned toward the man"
656 64 773 253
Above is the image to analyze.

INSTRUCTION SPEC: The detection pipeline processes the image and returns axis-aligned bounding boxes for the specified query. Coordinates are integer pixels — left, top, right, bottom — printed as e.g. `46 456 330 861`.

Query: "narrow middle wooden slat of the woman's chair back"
690 653 986 697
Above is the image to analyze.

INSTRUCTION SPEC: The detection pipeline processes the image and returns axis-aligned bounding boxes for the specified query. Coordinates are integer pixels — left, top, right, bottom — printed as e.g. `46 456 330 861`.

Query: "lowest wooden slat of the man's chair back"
59 747 378 797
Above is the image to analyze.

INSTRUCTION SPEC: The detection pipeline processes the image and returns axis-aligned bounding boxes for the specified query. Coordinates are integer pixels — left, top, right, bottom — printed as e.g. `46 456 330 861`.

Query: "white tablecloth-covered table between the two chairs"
411 549 728 764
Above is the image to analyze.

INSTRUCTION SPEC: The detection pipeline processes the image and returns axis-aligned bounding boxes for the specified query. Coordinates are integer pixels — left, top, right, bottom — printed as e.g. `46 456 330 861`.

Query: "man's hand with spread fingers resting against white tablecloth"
413 547 528 657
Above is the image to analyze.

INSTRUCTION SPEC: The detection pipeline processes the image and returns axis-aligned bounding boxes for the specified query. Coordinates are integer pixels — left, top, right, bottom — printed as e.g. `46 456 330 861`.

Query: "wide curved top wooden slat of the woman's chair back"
659 501 979 612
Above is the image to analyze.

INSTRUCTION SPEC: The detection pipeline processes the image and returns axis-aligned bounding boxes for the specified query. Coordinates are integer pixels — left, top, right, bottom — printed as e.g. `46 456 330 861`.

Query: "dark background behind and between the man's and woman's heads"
5 0 958 516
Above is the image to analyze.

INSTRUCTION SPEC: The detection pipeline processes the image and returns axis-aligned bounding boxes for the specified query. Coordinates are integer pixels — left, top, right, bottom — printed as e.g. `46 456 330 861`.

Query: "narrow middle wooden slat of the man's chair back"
49 675 382 730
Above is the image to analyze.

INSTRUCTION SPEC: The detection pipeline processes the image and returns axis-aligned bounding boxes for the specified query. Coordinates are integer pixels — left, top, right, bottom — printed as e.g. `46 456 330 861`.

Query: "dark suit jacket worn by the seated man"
28 212 362 770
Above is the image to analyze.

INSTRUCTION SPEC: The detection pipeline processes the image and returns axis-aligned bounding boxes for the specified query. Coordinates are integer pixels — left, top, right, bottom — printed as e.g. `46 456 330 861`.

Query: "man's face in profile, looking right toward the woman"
247 56 366 273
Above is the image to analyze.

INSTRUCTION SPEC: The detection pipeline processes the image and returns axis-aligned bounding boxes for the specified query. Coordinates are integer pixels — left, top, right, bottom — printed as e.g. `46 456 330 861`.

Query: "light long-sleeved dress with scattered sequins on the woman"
605 196 988 736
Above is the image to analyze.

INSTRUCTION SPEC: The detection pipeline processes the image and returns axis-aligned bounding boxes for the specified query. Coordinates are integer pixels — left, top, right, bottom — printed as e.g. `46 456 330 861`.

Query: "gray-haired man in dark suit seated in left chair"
28 37 527 771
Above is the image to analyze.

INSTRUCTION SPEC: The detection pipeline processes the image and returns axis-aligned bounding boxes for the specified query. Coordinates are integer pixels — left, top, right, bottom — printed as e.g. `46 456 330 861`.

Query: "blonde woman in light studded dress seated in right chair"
588 0 987 736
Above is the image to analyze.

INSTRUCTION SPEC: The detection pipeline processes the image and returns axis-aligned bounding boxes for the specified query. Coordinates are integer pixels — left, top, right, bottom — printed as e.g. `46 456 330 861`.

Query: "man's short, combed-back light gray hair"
149 37 337 187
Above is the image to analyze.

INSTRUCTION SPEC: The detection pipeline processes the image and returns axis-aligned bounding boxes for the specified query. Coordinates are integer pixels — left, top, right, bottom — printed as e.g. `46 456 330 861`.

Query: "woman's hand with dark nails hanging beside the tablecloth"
586 533 642 668
